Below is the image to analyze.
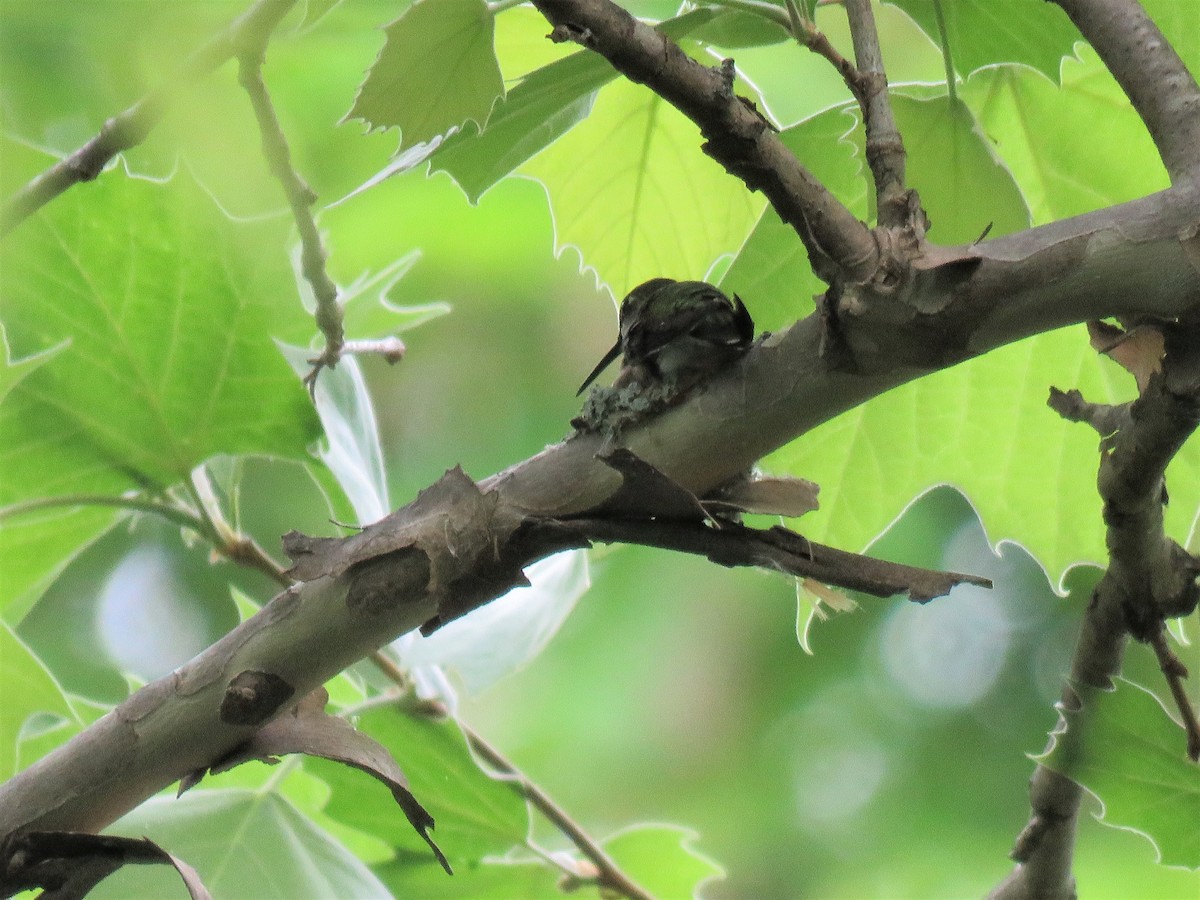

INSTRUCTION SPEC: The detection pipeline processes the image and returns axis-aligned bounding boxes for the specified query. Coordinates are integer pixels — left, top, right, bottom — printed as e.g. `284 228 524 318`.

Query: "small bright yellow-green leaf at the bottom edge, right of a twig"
604 826 725 896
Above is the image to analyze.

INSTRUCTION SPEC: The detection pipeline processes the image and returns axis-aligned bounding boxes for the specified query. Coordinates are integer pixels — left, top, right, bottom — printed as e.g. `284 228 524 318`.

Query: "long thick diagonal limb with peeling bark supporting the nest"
0 157 1200 859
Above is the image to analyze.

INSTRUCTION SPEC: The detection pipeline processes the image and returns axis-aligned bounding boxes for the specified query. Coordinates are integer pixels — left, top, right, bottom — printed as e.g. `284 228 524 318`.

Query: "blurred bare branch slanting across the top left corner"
0 0 296 236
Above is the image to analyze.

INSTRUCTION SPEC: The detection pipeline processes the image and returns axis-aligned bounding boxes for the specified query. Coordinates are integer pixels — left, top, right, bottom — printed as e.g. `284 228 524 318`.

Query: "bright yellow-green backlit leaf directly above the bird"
523 77 762 296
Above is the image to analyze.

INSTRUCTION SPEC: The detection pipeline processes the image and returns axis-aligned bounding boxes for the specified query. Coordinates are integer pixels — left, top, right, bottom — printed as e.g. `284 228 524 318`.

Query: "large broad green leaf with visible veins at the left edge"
0 173 317 494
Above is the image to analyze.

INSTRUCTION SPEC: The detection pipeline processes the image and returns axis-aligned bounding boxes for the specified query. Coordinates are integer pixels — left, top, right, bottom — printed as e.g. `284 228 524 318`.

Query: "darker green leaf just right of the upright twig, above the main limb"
892 94 1030 244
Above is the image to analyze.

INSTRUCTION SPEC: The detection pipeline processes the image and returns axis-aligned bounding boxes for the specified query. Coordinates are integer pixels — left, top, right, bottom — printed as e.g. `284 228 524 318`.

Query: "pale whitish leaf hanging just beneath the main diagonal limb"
396 551 590 694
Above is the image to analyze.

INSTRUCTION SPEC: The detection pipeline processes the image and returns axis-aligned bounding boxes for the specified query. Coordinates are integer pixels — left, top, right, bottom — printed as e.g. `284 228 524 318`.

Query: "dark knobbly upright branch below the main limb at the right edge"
991 326 1200 900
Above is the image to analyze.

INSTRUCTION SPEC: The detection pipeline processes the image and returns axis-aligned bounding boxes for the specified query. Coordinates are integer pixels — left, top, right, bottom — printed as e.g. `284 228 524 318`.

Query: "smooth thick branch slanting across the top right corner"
1056 0 1200 184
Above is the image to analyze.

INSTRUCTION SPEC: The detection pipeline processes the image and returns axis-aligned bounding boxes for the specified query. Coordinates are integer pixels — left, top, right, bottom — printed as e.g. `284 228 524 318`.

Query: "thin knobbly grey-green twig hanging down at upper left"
238 25 346 392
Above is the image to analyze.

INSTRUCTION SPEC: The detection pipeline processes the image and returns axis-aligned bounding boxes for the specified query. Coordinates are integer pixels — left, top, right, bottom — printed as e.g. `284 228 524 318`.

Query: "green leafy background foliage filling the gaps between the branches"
0 0 1200 898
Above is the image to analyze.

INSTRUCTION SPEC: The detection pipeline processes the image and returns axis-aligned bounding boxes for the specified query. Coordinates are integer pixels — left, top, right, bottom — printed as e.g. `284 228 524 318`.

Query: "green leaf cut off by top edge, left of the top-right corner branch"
889 0 1082 82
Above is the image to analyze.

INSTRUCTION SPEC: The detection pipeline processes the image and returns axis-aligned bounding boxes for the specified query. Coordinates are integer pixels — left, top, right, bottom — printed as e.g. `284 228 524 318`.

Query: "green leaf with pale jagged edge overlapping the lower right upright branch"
1034 679 1200 869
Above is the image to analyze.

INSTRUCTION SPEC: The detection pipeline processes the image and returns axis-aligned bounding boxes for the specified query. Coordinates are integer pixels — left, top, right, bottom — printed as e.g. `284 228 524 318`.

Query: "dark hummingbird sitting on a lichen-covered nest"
575 278 754 396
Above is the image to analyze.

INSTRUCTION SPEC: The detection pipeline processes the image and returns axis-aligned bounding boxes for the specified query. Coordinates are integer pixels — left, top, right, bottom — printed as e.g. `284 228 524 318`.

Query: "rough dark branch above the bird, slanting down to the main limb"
534 0 877 281
